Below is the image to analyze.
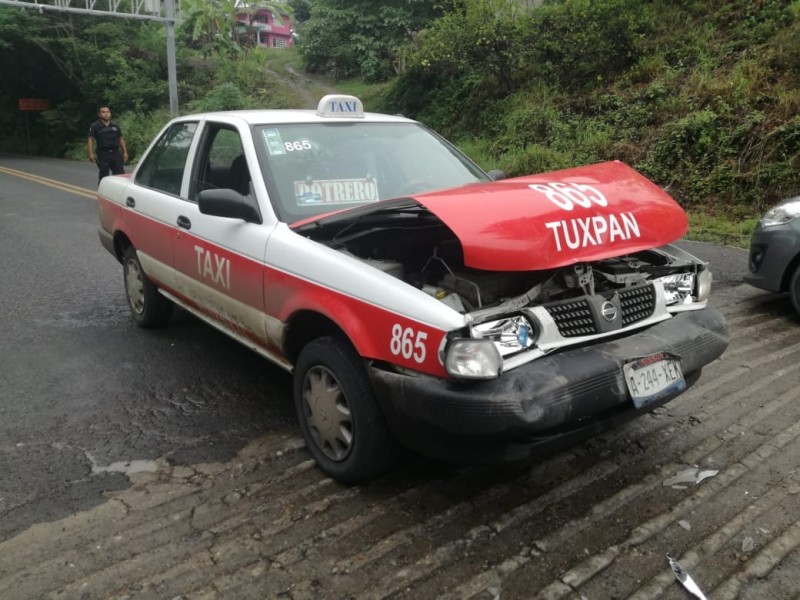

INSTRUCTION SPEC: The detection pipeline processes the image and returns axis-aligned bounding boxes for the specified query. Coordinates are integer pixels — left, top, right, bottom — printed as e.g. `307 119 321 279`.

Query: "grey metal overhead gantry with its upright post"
0 0 181 117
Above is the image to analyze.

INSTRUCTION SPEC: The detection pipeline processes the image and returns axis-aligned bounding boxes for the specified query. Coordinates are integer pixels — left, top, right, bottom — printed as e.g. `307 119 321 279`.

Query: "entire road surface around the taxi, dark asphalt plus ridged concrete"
0 156 800 600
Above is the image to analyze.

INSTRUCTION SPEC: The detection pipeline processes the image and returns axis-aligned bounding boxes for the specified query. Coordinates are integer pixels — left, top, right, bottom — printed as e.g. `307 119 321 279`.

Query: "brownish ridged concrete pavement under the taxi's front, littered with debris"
0 276 800 600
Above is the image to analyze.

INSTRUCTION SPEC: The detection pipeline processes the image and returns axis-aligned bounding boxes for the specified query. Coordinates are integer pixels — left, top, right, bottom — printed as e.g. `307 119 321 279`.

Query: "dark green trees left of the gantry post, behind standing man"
0 8 173 156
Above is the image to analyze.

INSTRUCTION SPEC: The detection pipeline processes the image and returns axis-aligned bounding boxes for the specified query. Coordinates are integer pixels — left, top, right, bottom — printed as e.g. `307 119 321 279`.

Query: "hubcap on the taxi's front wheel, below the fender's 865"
303 366 353 461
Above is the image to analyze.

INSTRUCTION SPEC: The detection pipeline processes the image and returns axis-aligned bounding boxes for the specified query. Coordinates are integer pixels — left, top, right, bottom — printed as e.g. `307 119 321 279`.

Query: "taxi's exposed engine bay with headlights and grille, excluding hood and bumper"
294 190 712 380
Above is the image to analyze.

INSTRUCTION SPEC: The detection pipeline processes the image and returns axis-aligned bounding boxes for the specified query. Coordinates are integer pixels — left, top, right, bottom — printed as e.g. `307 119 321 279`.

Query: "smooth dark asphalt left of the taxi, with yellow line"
0 156 295 539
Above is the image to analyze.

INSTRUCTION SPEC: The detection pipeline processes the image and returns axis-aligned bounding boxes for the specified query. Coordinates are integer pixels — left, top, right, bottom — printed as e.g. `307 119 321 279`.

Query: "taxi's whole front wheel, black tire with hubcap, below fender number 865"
294 337 398 483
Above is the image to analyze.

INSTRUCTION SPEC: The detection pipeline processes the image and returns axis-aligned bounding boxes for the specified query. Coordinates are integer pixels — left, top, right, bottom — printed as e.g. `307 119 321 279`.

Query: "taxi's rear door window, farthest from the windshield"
135 122 197 196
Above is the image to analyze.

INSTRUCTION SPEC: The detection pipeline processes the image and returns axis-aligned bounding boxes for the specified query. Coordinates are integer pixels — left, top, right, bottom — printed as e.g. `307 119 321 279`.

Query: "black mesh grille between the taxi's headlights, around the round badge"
544 284 656 337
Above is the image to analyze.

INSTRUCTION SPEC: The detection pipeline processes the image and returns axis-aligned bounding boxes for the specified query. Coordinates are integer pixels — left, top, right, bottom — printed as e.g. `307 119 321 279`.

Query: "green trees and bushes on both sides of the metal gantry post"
0 0 302 161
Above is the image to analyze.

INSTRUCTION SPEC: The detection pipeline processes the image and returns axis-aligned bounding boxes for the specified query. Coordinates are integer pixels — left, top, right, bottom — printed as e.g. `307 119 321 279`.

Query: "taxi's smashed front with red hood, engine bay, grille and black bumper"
296 163 728 461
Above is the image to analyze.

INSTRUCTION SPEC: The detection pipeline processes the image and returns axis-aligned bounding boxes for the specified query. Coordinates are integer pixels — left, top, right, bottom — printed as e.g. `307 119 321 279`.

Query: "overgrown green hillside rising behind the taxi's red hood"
366 0 800 244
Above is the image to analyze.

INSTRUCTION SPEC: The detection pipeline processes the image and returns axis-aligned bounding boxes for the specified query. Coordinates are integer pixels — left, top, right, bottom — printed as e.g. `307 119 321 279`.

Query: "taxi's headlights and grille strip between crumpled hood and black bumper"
446 246 711 378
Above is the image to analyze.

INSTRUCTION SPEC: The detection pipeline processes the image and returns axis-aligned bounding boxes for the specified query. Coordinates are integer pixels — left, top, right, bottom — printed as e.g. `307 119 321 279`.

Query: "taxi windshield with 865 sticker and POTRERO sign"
254 123 489 223
